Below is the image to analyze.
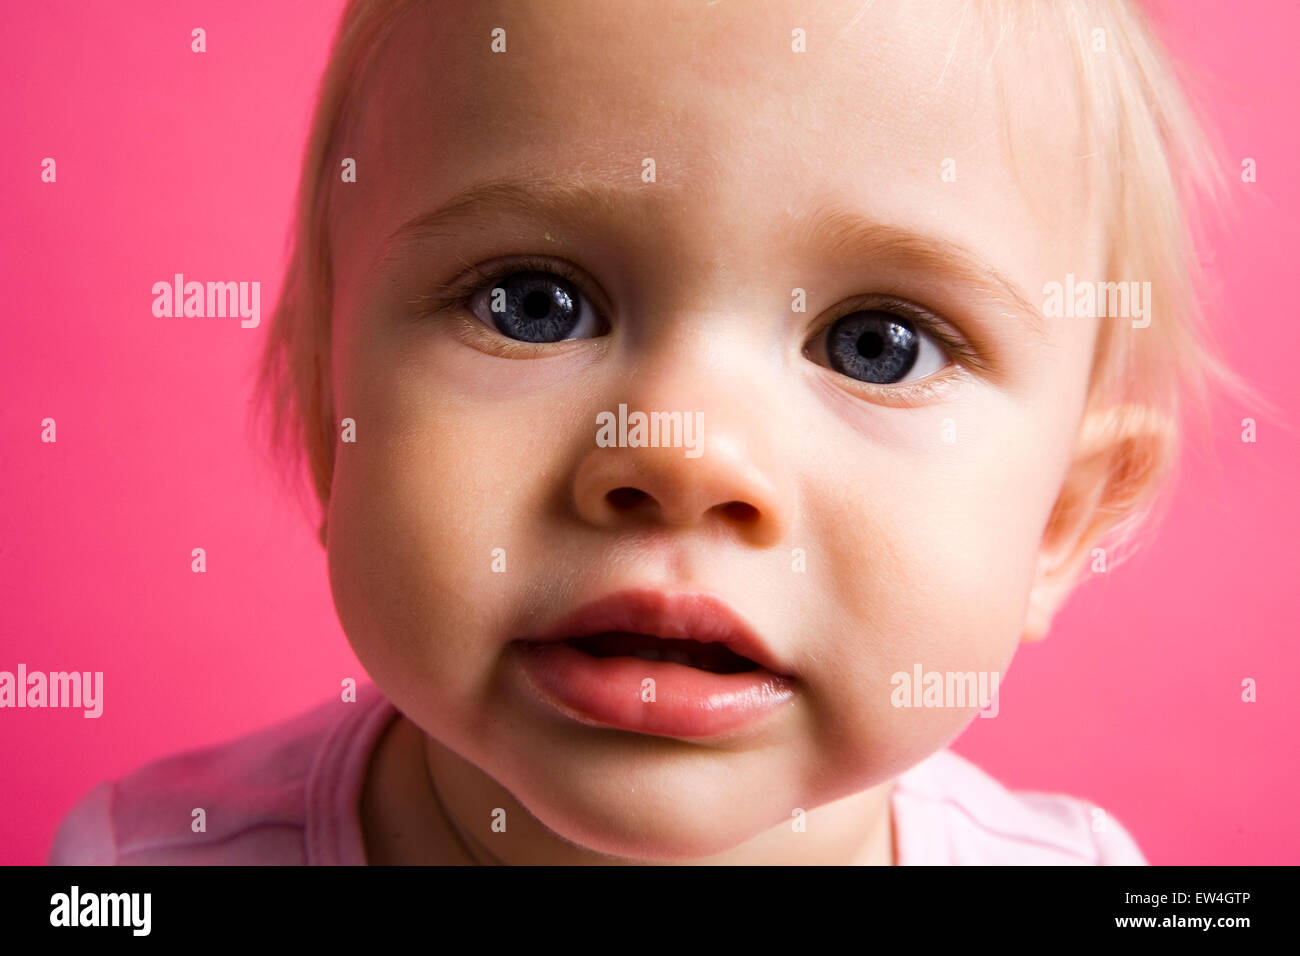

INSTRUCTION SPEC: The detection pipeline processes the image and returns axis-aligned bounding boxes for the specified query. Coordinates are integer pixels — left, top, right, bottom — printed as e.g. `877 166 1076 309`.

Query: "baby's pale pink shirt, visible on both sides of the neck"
49 684 1147 866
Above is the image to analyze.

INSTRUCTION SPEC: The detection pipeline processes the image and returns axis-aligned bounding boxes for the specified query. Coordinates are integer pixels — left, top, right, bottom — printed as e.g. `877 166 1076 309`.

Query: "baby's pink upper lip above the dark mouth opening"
521 588 785 675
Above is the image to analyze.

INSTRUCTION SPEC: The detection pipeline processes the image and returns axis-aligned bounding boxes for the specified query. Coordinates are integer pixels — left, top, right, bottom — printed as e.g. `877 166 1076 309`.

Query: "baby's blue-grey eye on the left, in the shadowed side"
468 272 599 342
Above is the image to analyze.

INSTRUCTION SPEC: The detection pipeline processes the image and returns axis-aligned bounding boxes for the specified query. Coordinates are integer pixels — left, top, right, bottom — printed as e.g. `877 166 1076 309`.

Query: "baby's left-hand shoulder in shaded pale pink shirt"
49 684 395 865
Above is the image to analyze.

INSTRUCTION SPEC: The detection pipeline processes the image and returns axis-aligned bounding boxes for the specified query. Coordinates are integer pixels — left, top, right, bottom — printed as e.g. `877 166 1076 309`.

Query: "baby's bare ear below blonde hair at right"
1023 405 1178 641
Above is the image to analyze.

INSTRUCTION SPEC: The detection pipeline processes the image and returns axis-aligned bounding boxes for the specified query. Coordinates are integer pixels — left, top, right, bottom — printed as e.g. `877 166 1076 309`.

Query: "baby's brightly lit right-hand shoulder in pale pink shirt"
893 749 1147 866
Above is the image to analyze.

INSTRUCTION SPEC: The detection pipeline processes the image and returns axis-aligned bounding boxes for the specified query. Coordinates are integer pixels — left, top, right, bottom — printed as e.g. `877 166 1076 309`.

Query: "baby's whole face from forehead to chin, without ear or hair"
328 0 1102 858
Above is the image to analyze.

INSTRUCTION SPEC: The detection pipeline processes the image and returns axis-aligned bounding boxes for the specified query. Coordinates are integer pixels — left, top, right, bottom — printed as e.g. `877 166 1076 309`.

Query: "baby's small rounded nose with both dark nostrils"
573 405 793 548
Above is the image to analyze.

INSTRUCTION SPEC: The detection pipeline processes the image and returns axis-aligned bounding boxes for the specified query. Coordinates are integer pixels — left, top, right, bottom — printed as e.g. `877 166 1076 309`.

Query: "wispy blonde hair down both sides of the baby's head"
255 0 1268 582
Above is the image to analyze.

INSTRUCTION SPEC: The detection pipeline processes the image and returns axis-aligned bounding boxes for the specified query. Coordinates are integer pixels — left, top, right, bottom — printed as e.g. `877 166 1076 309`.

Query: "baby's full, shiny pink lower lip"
519 641 794 737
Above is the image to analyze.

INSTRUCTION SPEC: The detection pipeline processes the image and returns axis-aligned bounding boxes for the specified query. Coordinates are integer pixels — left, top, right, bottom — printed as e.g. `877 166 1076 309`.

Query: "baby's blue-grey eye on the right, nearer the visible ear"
826 310 948 385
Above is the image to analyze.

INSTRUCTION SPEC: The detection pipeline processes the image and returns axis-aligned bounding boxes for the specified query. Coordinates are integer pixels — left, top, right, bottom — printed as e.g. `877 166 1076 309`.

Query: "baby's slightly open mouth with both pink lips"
515 589 794 739
